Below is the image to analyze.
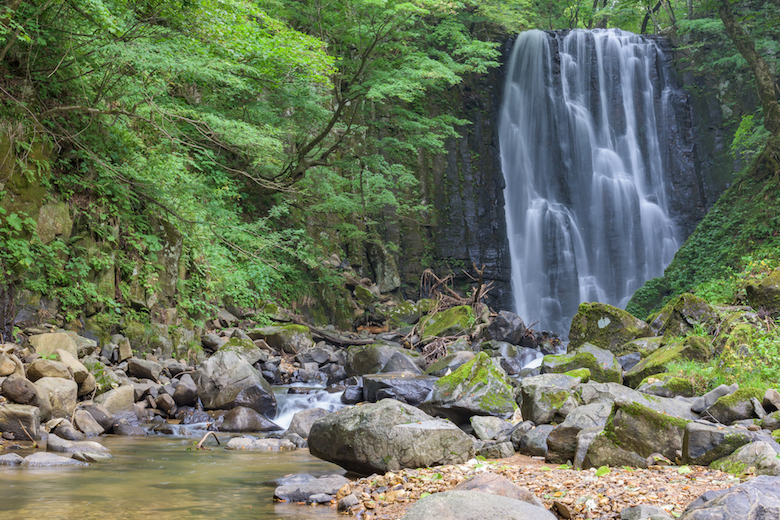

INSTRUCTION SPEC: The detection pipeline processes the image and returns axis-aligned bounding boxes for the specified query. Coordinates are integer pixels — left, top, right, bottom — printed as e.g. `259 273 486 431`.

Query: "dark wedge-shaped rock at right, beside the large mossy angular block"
682 422 780 466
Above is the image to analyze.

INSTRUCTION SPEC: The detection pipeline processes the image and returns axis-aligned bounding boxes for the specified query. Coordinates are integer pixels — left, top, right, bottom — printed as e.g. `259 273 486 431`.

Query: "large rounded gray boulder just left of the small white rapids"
192 350 276 417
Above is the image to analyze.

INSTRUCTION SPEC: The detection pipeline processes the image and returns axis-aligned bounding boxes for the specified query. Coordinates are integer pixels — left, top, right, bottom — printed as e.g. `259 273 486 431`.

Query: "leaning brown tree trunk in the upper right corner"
718 0 780 136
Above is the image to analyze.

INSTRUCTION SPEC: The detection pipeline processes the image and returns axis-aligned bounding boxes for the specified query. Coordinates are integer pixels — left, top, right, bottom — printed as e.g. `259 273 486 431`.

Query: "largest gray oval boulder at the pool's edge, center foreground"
309 399 474 474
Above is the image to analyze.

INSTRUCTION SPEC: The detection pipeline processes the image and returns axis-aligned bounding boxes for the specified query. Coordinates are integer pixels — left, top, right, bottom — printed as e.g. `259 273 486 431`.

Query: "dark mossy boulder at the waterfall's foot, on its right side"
568 303 653 356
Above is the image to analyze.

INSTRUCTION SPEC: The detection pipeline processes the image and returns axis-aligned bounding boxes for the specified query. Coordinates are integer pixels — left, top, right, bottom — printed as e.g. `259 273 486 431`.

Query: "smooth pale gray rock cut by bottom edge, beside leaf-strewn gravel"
402 490 556 520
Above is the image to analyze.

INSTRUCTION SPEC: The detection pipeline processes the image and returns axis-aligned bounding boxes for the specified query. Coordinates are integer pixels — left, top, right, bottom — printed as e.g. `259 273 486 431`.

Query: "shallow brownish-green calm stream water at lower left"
0 434 344 520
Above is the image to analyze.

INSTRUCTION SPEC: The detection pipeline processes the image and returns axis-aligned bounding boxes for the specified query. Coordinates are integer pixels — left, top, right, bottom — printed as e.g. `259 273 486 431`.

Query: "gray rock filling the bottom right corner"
679 475 780 520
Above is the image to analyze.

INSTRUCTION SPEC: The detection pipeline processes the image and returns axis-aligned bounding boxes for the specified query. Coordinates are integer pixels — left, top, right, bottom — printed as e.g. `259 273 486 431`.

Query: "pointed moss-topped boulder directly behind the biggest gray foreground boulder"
420 352 517 424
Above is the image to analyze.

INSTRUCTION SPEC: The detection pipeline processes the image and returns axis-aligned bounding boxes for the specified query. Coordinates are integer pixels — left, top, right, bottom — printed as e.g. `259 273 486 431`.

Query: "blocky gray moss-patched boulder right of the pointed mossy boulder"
520 374 580 424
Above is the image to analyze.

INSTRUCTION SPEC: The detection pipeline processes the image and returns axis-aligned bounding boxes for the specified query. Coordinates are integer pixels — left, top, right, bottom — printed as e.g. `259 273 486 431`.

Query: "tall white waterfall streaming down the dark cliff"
499 29 680 334
